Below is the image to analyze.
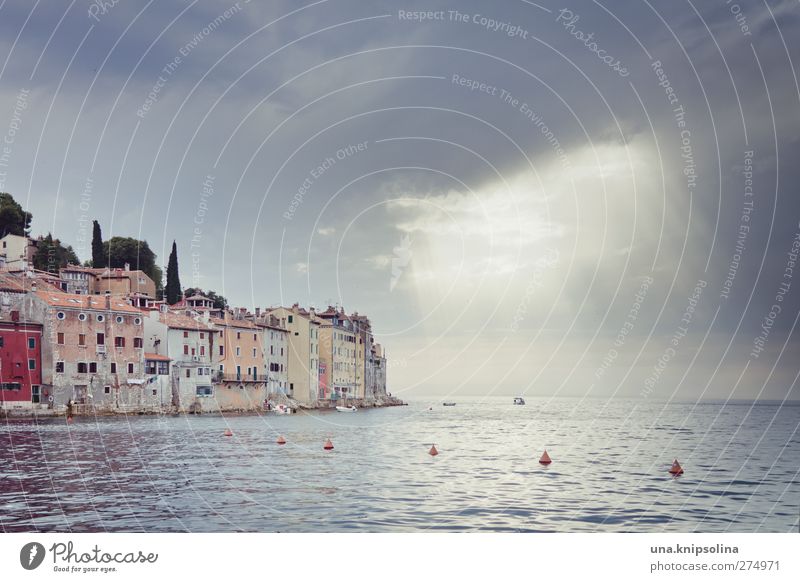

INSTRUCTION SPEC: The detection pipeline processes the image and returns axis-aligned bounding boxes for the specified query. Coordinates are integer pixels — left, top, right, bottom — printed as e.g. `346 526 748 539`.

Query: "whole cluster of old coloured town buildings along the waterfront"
0 217 401 416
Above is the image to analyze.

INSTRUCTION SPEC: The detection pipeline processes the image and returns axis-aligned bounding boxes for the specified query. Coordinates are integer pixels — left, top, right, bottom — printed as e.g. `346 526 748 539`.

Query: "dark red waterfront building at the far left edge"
0 310 43 411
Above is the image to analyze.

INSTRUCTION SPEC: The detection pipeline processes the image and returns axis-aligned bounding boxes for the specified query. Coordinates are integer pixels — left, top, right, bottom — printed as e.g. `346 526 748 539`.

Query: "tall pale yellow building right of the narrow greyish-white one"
267 303 318 405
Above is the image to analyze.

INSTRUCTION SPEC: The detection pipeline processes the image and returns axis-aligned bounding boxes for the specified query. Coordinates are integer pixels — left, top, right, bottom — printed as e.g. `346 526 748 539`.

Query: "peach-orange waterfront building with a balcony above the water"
206 310 267 410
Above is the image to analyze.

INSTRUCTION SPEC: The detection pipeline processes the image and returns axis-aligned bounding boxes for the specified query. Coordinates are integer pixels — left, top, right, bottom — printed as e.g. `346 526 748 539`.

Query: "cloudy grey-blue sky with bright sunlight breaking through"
0 0 800 401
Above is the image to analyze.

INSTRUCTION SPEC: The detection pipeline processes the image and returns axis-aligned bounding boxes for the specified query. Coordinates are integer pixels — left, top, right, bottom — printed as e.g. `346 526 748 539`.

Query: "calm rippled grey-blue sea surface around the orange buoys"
0 398 800 532
